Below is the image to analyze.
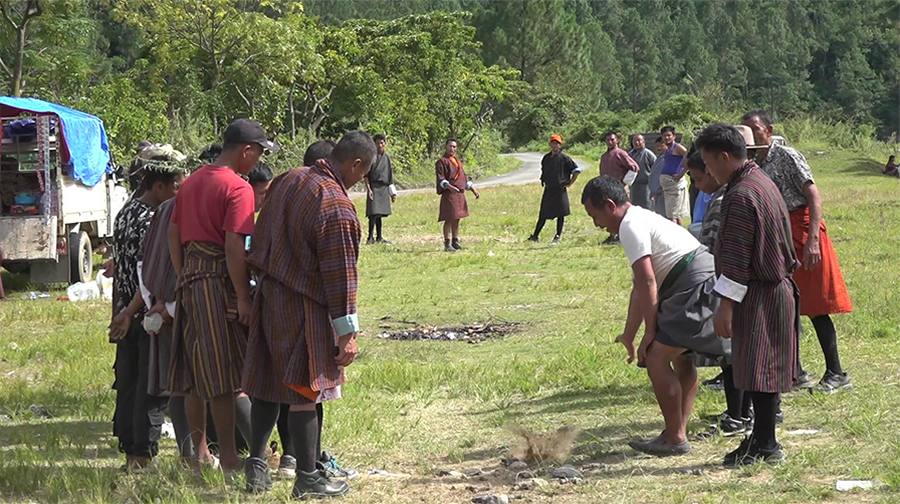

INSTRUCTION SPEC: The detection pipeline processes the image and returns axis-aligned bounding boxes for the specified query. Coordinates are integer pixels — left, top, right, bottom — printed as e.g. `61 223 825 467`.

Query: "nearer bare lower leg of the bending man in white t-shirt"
646 342 687 445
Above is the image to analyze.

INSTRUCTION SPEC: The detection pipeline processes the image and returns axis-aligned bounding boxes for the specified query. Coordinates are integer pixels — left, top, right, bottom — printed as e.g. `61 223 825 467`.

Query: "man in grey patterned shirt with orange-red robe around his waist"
742 110 853 394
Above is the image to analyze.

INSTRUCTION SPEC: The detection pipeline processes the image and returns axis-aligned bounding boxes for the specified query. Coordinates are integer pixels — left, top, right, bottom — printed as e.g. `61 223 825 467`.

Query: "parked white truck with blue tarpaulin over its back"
0 96 128 283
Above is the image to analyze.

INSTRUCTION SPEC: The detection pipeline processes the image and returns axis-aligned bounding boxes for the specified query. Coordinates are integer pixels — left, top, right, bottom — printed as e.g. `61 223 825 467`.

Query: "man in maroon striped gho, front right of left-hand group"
242 131 376 498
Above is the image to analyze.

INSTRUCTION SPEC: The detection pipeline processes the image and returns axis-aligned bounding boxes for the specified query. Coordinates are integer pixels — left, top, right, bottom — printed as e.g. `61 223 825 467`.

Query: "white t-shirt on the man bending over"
619 205 700 287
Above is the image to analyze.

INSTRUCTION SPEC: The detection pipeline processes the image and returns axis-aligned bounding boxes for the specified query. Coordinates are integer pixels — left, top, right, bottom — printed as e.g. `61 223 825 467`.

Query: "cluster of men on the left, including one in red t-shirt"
110 119 383 497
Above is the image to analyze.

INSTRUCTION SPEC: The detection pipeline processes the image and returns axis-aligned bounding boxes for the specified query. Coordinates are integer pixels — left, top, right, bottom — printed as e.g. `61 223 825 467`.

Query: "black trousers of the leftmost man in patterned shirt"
113 318 168 457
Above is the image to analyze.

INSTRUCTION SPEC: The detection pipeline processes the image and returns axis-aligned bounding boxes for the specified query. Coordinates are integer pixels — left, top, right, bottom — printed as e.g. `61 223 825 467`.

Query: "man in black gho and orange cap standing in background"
528 135 581 245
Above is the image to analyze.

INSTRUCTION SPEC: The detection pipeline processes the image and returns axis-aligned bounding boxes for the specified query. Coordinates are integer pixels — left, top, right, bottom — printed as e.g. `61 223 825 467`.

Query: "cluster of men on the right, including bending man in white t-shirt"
582 110 852 466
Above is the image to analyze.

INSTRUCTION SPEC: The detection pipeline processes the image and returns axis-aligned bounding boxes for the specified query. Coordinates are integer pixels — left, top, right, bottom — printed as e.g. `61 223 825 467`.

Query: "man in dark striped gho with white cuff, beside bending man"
694 123 800 467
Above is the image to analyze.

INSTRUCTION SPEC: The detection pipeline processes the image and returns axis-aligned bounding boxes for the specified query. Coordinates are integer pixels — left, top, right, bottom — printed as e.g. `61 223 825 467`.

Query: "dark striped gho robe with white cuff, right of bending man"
714 161 800 392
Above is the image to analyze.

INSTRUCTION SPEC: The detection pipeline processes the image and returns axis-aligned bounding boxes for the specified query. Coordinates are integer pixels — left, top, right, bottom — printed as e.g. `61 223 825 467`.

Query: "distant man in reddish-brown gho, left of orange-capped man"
434 138 481 252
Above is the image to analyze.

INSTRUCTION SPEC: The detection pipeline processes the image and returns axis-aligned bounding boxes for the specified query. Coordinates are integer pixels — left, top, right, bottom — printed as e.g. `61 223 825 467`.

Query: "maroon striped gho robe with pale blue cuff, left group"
242 160 360 404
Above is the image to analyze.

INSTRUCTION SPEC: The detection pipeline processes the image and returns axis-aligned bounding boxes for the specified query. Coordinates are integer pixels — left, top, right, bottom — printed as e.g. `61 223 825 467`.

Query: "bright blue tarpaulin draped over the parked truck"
0 96 113 186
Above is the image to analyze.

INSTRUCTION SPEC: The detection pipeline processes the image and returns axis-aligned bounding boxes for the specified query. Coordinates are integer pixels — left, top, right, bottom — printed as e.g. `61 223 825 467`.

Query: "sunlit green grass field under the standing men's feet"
0 148 900 503
